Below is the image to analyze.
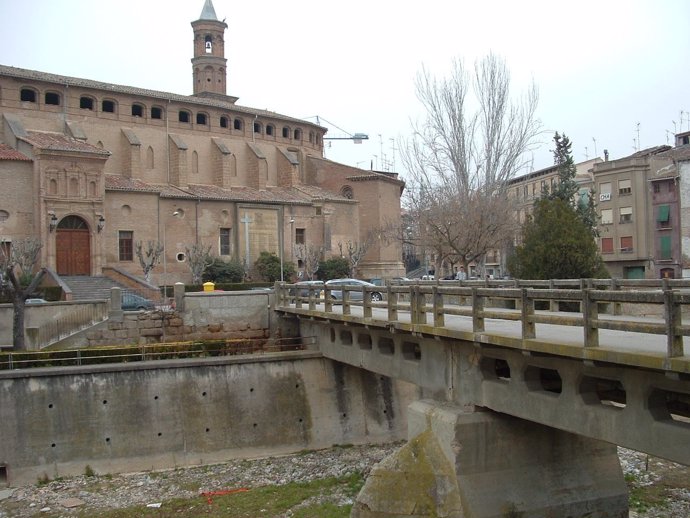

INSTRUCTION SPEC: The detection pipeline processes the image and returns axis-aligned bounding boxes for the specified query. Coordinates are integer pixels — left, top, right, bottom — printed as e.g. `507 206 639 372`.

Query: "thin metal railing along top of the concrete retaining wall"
0 337 314 371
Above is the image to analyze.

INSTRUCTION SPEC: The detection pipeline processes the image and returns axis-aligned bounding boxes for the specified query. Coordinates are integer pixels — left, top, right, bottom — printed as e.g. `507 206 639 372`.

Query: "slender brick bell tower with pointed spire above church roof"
192 0 228 96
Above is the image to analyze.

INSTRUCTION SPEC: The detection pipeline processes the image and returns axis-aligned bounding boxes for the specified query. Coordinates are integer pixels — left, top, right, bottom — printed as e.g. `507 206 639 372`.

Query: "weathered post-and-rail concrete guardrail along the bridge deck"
276 279 690 358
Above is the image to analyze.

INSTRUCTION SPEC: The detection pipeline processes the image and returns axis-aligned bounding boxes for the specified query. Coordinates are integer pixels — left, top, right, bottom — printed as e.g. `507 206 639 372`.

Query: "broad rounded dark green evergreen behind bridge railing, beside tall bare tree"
509 198 608 279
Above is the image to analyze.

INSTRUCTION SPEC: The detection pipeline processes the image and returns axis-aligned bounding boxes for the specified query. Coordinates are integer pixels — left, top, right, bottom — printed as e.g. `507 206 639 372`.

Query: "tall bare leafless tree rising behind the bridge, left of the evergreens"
401 54 540 276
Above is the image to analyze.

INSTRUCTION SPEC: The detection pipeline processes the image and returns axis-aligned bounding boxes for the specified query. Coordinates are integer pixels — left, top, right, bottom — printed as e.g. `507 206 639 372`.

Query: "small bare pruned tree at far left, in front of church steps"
0 238 45 350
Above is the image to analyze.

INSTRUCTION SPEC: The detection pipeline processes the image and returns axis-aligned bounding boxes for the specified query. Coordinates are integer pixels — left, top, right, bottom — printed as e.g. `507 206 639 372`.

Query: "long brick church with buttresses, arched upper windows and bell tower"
0 0 404 285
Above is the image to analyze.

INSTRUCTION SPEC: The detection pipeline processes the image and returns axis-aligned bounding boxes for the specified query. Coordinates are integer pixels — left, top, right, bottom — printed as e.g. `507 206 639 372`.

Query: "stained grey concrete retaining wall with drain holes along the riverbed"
0 351 417 485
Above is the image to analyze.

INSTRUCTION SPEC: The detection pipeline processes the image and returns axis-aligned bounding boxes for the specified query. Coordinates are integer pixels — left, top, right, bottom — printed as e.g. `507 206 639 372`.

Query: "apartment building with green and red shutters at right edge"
593 141 690 279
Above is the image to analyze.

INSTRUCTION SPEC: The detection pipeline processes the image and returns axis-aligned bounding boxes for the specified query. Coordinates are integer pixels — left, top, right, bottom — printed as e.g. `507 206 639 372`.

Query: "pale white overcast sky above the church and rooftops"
0 0 690 175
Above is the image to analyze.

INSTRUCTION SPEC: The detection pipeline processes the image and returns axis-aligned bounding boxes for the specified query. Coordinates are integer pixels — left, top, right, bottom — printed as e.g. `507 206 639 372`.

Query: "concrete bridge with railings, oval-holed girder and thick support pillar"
276 280 690 517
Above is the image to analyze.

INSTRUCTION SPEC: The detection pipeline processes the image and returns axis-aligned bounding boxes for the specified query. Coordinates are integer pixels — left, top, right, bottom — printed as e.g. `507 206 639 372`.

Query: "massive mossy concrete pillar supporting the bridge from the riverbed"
351 401 628 518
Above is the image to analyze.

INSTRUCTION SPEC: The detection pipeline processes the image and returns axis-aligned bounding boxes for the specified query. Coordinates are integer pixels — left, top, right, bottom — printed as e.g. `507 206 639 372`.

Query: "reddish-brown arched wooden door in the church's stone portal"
55 216 91 275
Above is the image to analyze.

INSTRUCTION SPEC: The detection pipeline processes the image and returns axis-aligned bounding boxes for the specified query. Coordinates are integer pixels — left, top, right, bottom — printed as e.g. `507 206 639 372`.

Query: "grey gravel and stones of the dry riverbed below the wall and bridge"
0 443 690 518
